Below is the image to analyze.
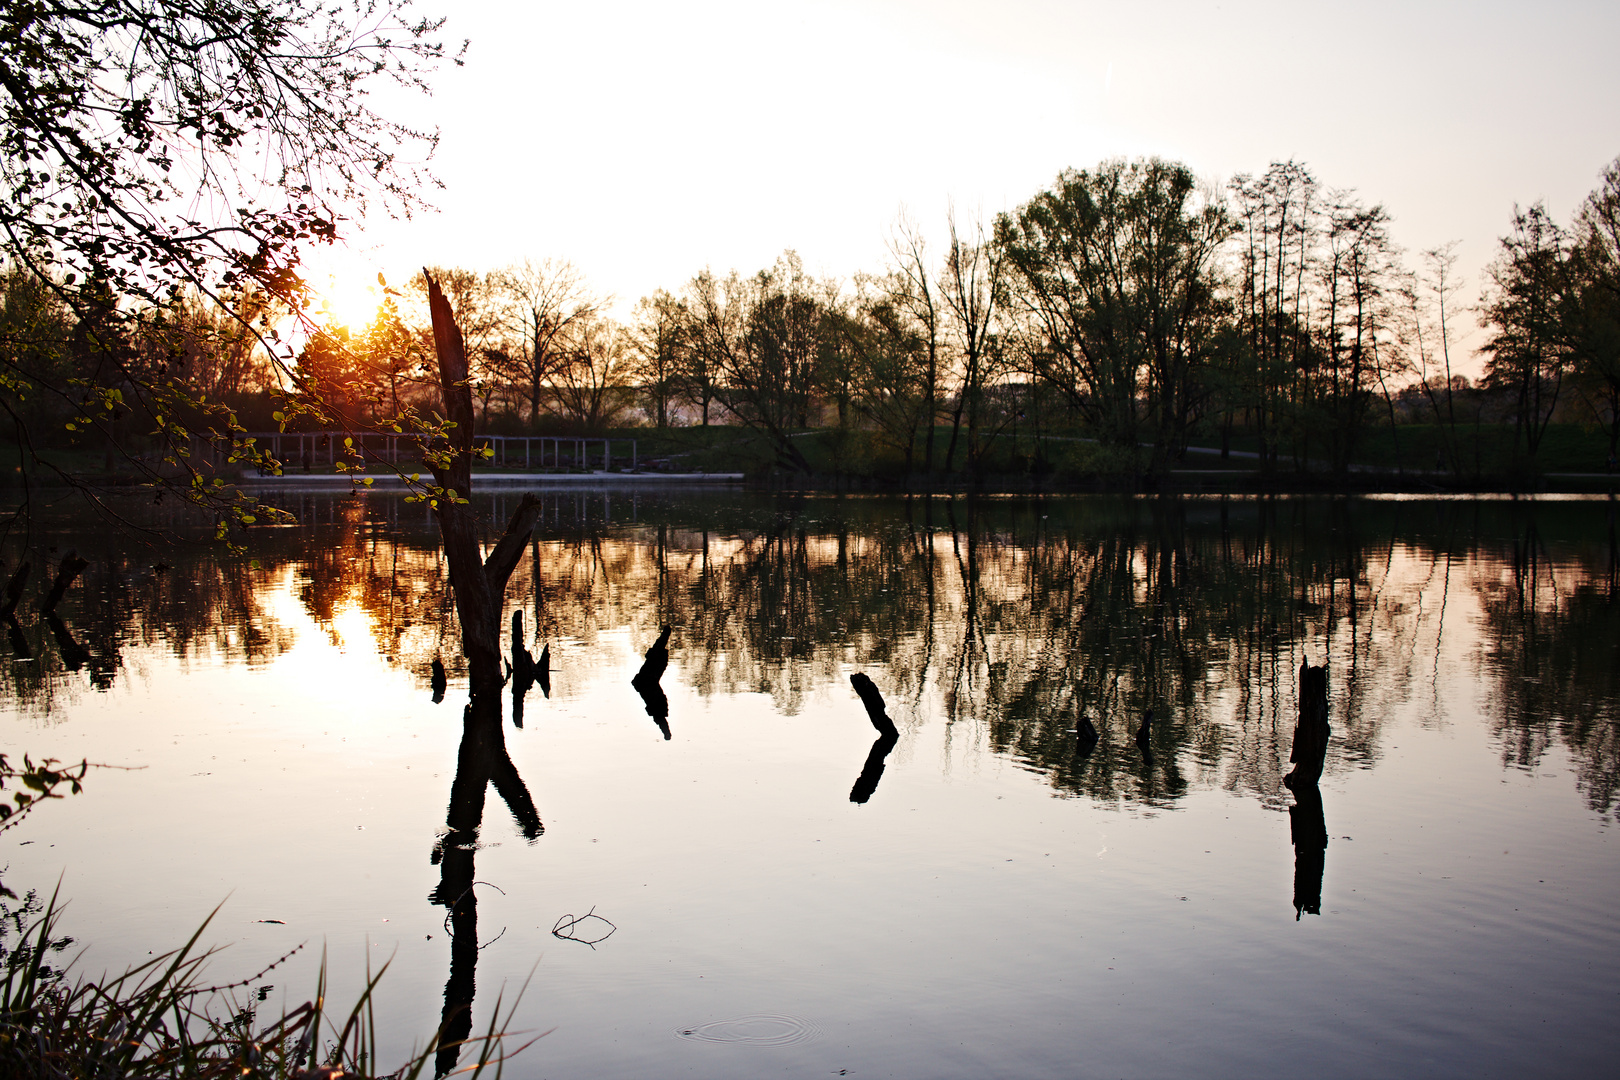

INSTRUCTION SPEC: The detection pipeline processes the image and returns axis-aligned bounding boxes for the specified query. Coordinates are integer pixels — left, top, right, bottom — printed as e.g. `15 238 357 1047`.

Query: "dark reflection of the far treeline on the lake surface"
0 491 1620 813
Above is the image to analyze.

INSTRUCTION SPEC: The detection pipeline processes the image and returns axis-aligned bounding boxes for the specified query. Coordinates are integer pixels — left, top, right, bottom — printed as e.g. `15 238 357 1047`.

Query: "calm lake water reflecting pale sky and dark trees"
0 491 1620 1080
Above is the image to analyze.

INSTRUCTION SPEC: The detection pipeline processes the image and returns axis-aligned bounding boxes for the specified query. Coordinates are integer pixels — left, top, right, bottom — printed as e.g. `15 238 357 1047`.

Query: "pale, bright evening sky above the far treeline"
309 0 1620 372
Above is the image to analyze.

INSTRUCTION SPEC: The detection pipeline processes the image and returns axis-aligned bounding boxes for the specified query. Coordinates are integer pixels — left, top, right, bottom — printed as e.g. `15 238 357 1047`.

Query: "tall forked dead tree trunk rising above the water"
424 270 539 727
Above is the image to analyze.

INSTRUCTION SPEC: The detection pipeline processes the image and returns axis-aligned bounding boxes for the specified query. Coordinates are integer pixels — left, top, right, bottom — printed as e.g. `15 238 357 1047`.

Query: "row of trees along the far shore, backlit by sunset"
0 159 1620 474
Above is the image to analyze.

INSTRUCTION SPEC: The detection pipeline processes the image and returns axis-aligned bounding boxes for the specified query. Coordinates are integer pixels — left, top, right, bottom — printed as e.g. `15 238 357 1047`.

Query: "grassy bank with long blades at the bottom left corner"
0 892 538 1080
